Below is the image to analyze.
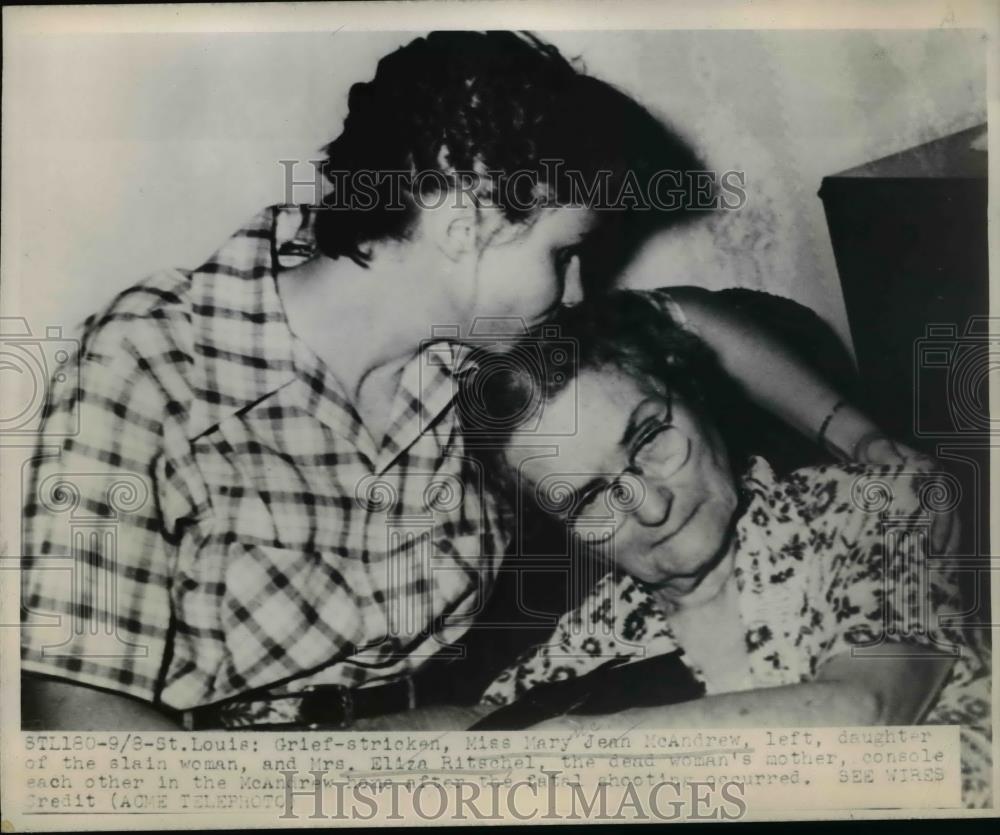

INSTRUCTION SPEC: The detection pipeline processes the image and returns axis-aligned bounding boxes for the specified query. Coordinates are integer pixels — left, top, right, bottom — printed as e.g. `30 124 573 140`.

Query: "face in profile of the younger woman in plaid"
468 207 597 335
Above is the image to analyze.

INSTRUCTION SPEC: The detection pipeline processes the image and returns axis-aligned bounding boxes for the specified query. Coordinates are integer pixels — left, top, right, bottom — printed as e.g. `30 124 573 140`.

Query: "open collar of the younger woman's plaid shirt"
188 206 474 470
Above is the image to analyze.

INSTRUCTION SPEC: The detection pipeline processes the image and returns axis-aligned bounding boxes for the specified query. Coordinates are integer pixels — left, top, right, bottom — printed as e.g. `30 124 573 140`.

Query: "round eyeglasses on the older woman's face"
538 401 691 530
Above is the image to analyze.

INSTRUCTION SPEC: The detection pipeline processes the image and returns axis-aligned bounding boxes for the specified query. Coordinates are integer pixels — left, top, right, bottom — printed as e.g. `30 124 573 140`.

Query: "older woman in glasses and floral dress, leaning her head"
466 293 990 805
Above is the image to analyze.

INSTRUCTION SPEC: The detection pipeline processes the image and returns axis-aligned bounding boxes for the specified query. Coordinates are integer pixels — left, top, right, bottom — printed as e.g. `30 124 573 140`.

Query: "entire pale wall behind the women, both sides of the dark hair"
3 30 986 344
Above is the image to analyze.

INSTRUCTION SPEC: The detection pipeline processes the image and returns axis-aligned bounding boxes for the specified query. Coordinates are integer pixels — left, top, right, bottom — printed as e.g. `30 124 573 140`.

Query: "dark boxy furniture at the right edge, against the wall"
819 125 1000 620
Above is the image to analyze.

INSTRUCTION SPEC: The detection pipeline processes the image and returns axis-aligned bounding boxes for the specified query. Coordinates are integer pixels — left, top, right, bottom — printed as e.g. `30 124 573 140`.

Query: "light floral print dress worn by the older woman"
483 458 992 807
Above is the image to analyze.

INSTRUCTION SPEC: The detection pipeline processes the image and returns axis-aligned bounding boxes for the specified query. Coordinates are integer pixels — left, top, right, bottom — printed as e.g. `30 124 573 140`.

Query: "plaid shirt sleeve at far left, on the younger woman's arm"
21 317 178 701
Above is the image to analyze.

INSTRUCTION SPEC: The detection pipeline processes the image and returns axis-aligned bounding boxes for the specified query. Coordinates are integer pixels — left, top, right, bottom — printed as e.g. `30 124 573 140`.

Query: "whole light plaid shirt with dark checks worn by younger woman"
22 207 505 709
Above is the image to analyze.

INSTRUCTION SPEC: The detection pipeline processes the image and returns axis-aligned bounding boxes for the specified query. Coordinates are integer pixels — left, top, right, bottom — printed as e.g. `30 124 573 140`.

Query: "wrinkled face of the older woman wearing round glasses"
507 368 737 593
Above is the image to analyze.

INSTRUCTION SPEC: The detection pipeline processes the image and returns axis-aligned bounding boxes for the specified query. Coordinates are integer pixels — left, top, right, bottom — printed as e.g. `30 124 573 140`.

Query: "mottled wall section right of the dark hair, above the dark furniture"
581 31 986 338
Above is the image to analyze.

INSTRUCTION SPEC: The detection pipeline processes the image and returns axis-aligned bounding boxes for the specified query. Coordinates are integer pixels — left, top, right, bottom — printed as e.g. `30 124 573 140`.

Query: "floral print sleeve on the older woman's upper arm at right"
810 466 962 671
